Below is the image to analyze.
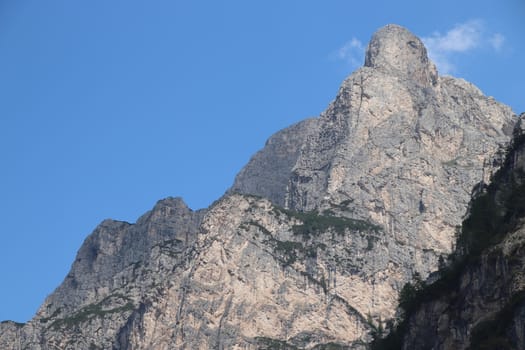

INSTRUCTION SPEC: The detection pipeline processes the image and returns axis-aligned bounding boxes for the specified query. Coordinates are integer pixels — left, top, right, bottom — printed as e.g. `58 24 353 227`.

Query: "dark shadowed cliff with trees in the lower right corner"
390 115 525 349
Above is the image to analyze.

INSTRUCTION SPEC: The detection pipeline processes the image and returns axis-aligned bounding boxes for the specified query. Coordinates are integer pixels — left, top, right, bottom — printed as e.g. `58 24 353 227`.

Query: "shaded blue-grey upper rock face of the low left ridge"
41 198 204 317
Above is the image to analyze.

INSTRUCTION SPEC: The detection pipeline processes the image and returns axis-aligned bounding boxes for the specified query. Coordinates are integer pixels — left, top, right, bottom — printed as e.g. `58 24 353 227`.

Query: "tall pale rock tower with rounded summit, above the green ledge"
235 21 515 336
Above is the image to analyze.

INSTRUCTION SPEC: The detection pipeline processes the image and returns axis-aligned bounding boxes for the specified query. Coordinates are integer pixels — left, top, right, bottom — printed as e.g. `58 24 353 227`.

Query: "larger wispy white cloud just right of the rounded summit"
422 20 505 74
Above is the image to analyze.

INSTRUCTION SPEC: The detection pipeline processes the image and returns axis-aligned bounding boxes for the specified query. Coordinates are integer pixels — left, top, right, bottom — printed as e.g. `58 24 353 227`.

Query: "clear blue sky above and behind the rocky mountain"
0 0 525 322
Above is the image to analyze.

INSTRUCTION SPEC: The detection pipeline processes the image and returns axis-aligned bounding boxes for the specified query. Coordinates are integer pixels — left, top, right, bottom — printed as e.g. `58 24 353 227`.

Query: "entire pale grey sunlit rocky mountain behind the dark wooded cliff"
0 25 518 349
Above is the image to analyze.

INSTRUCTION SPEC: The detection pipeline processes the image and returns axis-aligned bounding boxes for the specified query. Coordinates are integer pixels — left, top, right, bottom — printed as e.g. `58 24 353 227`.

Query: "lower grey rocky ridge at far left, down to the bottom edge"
0 198 205 349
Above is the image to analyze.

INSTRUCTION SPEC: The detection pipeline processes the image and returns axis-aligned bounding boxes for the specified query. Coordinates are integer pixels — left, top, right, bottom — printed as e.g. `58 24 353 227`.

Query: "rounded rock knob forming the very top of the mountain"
365 24 437 86
